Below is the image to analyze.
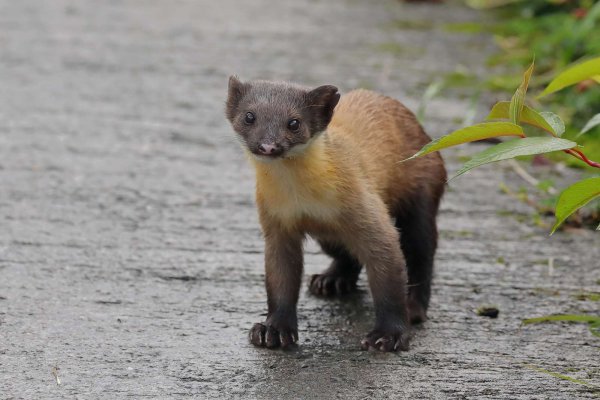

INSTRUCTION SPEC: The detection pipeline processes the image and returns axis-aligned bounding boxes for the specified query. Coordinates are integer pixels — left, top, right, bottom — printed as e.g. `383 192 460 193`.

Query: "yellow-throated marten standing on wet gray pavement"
226 77 446 351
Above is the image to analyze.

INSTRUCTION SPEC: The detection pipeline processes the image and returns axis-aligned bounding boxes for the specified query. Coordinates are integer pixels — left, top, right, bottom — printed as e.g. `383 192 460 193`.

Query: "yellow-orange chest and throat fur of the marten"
254 138 341 226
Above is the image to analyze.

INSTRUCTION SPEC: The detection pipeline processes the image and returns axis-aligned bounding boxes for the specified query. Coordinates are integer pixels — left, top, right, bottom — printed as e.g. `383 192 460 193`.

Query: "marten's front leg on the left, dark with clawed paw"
250 220 303 348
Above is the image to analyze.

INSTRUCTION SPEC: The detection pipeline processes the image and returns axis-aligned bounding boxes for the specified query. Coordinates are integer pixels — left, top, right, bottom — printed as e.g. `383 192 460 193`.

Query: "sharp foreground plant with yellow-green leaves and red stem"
404 57 600 234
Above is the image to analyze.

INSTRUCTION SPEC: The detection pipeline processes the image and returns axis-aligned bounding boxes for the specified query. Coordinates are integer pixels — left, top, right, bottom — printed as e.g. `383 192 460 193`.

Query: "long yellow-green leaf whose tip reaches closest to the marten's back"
402 122 523 162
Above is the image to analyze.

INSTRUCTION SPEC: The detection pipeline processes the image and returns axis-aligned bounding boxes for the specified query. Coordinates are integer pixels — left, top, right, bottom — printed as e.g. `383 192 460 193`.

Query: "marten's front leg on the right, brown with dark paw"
346 199 410 351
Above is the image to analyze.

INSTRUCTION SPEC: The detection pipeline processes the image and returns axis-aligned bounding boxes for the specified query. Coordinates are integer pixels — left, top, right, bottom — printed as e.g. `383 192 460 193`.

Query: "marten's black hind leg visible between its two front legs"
308 240 362 296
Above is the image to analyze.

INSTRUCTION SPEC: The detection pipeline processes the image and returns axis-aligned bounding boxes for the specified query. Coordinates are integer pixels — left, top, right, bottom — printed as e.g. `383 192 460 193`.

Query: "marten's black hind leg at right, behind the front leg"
395 194 438 323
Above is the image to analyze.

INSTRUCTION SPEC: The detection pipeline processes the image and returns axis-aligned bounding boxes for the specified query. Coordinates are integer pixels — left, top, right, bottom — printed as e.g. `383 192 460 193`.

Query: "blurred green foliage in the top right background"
462 0 600 167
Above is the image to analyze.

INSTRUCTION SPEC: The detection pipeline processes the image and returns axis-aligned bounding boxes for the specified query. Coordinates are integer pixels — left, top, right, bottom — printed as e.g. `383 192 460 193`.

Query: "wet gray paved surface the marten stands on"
0 0 600 399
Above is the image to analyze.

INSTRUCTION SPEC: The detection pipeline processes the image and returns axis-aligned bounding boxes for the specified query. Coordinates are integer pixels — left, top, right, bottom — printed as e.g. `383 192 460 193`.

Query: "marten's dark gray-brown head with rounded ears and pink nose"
225 76 340 160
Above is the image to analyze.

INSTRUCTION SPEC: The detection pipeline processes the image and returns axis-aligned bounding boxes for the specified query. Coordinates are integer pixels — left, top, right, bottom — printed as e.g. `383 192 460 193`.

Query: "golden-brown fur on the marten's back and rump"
328 89 446 216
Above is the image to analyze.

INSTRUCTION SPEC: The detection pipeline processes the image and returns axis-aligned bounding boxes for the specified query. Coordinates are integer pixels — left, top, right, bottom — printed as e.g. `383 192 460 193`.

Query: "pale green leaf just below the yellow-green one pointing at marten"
449 137 577 180
